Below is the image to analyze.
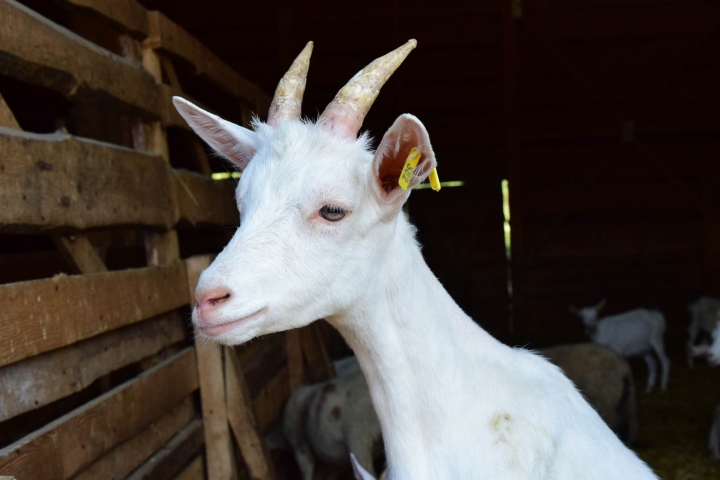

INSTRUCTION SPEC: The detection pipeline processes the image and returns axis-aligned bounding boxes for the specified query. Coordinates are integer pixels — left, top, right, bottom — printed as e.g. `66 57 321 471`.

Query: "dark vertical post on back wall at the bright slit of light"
498 0 527 333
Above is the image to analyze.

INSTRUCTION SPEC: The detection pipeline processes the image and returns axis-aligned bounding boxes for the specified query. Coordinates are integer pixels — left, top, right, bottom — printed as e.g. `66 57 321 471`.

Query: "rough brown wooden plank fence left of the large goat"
0 0 333 480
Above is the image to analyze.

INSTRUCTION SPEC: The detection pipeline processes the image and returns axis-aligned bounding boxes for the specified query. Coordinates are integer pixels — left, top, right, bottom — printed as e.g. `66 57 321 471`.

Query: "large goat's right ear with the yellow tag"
372 113 437 206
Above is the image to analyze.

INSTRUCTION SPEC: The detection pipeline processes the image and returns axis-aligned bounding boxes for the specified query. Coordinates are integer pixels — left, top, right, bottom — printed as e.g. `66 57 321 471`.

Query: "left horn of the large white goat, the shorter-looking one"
268 42 313 127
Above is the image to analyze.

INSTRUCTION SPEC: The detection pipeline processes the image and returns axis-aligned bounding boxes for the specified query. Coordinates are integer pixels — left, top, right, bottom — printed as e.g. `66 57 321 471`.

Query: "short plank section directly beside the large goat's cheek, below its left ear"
174 170 239 226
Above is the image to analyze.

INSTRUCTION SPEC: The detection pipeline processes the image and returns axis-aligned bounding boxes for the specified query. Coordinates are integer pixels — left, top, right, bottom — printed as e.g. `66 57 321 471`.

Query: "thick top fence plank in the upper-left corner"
0 0 160 118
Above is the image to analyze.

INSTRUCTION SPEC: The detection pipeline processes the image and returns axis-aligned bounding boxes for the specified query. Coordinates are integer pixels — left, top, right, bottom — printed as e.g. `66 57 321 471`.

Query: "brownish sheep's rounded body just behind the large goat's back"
539 343 637 445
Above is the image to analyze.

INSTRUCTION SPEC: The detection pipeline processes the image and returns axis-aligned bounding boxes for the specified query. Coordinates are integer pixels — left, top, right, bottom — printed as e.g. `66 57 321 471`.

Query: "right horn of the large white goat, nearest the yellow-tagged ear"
319 39 417 138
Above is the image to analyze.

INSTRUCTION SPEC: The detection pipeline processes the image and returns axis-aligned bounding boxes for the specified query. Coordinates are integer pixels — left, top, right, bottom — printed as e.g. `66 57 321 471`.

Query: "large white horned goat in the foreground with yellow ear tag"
175 40 657 480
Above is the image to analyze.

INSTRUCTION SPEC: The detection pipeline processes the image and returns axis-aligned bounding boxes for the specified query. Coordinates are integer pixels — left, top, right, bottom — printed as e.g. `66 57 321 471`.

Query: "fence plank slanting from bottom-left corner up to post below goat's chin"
0 348 198 480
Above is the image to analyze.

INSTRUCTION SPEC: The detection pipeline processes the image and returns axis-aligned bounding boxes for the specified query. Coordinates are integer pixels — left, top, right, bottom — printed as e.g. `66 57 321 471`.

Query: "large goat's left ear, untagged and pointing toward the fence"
173 97 258 170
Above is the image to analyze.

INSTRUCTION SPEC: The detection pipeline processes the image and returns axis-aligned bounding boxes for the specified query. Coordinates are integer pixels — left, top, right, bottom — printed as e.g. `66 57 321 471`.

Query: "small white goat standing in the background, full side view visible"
570 300 670 392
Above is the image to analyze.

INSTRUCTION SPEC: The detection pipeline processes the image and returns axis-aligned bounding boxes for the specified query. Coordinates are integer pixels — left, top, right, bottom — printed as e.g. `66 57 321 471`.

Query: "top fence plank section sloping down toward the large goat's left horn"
144 11 267 107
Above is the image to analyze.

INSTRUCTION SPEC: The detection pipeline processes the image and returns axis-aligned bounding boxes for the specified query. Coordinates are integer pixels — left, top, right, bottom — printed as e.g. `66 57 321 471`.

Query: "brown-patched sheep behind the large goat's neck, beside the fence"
283 357 382 480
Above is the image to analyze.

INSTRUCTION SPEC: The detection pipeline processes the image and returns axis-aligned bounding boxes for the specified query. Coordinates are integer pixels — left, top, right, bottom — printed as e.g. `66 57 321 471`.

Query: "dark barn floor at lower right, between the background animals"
632 350 720 480
